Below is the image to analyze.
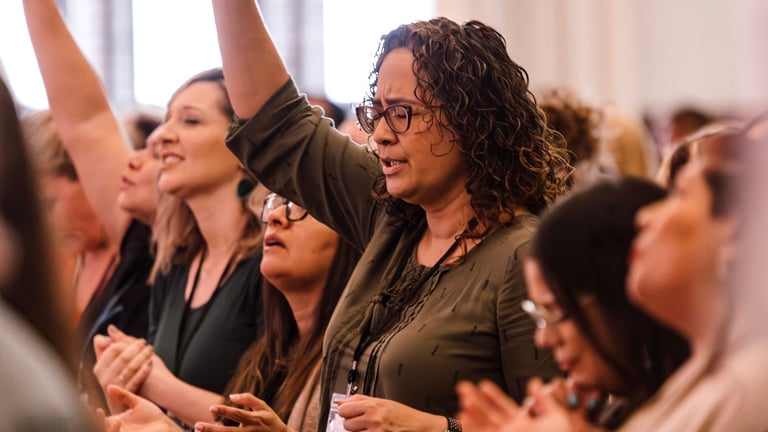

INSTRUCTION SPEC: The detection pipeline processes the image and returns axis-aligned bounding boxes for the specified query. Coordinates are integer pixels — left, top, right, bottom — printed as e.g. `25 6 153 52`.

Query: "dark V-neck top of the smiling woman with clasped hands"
149 253 264 393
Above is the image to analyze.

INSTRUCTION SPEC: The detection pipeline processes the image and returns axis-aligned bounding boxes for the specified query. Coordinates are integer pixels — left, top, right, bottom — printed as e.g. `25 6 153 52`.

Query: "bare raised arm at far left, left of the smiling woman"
24 0 130 244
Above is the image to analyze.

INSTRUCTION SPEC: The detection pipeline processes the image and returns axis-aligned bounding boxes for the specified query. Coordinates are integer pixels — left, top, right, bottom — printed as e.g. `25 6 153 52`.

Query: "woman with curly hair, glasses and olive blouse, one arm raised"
213 0 570 431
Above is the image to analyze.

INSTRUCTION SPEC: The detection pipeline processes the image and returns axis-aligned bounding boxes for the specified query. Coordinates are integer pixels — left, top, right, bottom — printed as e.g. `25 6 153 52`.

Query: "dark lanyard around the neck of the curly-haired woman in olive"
347 218 477 398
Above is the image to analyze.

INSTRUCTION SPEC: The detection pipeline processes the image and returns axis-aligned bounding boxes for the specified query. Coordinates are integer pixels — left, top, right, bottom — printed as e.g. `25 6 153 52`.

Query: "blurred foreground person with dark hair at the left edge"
0 80 95 432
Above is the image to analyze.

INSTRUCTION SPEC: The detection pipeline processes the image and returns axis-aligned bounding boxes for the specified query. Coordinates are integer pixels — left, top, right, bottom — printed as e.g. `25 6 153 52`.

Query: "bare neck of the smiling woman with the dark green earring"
187 178 249 256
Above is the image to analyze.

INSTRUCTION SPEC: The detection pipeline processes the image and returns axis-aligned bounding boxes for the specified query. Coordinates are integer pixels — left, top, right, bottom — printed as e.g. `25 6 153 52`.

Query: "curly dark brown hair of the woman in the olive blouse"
367 18 572 238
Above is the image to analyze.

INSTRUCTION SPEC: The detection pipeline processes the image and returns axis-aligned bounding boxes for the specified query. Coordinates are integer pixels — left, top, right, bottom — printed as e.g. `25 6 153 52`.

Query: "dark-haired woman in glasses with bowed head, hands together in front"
457 177 688 432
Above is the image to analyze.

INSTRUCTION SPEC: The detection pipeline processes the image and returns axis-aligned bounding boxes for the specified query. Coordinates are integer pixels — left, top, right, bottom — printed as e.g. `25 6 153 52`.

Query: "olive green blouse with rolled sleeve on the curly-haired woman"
227 80 558 431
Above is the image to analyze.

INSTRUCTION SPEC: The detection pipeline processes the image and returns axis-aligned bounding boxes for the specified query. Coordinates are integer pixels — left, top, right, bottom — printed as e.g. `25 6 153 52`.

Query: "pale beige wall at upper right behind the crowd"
435 0 768 117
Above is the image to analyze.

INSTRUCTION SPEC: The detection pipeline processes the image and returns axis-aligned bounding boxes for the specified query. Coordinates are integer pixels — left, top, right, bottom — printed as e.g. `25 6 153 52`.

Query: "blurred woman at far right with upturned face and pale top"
622 123 768 431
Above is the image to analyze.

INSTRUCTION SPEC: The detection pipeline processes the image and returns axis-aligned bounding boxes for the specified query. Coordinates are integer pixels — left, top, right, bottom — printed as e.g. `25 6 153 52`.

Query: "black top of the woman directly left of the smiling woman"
77 219 153 406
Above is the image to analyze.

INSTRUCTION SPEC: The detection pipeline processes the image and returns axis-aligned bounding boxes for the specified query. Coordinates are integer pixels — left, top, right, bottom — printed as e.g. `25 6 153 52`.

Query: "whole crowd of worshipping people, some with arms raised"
0 0 768 432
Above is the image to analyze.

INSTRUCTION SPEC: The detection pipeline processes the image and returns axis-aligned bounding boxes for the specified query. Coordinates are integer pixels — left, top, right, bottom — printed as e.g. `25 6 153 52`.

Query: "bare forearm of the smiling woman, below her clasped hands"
140 374 223 426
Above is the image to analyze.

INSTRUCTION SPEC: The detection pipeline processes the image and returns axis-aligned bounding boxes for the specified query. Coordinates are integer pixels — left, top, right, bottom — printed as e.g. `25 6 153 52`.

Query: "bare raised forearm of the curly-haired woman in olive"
210 0 288 118
